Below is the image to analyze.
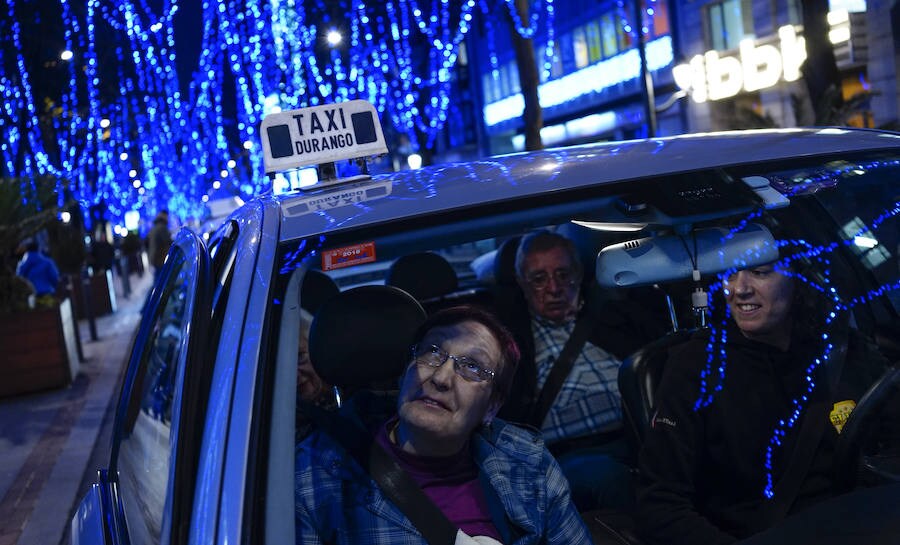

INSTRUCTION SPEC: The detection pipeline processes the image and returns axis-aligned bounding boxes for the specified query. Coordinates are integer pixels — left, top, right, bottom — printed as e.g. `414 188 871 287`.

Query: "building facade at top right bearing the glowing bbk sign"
673 0 897 132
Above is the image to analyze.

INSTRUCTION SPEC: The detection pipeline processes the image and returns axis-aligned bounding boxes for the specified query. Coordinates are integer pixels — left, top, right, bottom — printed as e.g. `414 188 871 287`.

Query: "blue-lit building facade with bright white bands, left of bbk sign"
467 0 685 154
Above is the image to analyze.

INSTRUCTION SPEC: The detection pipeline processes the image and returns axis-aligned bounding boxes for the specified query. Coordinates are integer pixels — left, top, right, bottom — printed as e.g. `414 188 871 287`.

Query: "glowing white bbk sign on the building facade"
672 10 850 102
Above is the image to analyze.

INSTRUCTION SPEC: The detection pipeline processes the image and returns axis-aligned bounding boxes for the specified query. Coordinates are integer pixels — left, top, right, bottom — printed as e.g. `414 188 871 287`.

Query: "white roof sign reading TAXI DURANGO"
260 100 388 174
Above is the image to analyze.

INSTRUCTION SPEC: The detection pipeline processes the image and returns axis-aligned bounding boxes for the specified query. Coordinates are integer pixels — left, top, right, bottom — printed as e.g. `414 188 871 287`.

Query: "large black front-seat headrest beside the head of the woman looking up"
309 286 425 388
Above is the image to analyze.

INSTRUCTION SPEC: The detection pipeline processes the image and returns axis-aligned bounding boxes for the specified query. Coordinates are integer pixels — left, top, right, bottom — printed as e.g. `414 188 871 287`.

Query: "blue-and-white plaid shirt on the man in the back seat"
531 318 622 444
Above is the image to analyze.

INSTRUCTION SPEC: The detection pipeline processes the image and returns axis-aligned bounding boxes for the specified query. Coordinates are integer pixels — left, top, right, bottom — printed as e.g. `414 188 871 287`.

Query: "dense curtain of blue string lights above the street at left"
0 0 500 222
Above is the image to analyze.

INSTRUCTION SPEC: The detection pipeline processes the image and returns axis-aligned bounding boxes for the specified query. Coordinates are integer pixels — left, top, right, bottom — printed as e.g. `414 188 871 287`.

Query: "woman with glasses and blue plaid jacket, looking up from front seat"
296 307 591 545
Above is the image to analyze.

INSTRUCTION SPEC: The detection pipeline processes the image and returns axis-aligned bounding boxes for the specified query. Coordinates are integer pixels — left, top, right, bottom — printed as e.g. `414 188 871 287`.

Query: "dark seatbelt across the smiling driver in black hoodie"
763 324 847 527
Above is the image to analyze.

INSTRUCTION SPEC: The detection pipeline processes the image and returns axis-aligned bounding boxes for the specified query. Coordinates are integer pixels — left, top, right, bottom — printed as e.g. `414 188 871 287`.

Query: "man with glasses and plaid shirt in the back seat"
500 231 634 510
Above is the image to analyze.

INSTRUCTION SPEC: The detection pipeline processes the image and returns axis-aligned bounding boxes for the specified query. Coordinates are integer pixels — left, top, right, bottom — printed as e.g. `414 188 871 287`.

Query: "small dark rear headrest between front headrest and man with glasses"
384 252 459 301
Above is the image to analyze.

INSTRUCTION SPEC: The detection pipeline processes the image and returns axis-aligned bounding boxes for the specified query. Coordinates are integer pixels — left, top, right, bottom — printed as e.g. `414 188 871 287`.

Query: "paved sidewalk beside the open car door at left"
0 271 153 545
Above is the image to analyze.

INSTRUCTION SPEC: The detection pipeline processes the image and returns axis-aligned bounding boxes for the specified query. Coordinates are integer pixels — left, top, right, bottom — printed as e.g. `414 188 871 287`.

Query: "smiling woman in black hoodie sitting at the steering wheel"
638 262 887 545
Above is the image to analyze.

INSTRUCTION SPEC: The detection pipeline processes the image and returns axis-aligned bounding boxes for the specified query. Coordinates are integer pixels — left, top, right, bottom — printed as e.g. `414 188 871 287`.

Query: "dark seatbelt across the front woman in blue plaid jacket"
298 401 459 545
